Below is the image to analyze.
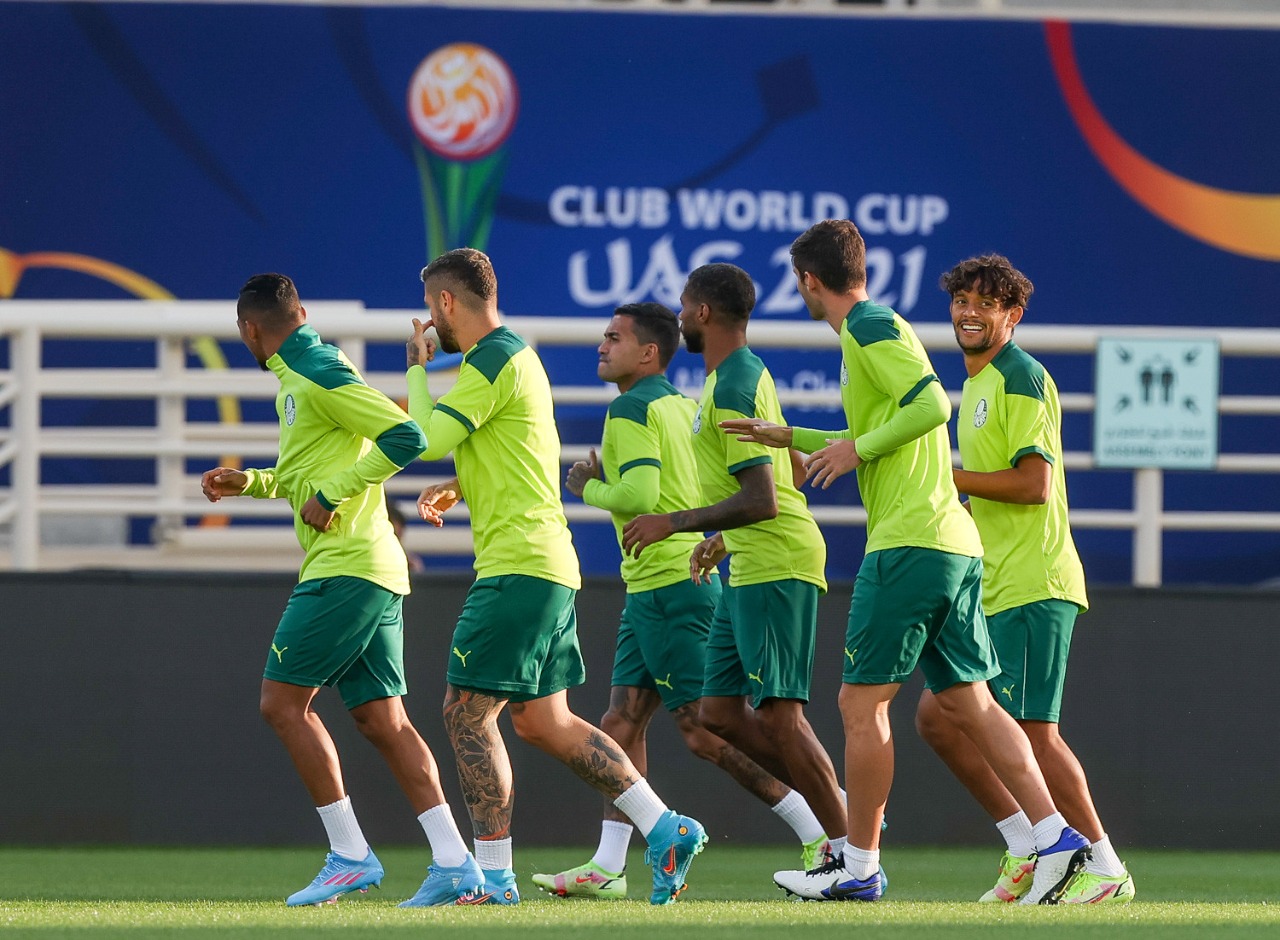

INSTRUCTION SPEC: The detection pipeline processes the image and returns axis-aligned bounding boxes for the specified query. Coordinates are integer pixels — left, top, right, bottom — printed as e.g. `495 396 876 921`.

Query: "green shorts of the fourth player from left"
703 579 818 708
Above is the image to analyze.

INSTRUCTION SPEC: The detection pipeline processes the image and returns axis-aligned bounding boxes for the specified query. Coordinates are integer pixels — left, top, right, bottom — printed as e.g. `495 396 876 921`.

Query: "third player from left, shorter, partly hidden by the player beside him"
534 304 827 898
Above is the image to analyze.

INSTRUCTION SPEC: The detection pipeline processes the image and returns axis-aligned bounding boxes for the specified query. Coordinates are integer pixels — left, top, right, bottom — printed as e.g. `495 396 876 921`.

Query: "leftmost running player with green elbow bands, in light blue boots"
200 274 481 905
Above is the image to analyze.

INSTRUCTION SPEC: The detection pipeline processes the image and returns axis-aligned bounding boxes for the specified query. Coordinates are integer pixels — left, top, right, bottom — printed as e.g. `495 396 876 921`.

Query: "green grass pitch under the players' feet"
0 844 1280 940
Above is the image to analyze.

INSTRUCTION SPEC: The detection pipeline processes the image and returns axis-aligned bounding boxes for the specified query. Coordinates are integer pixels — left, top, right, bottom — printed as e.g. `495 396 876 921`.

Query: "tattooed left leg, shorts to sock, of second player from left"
444 685 515 839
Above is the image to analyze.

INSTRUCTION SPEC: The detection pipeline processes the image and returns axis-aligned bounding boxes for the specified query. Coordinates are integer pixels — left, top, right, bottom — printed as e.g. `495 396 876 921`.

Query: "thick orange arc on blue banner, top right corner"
1044 22 1280 261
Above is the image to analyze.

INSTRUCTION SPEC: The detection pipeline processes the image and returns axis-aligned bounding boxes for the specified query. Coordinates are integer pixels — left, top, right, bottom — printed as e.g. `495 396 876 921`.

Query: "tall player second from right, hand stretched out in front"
726 220 1088 903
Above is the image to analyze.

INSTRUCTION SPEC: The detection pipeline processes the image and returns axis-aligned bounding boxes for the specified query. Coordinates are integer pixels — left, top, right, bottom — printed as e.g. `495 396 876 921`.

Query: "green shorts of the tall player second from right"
842 547 1000 692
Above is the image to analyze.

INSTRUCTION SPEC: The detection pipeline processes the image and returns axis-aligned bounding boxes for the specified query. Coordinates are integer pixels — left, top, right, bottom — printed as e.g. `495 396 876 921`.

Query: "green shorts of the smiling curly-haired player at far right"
987 599 1080 724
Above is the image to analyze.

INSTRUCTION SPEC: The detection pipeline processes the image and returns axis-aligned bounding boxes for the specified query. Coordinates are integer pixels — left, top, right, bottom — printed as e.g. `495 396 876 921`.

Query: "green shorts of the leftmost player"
262 576 407 708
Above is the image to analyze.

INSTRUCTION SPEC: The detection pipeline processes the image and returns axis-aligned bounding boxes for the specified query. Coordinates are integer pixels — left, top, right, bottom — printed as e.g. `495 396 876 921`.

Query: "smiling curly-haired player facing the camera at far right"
916 255 1134 904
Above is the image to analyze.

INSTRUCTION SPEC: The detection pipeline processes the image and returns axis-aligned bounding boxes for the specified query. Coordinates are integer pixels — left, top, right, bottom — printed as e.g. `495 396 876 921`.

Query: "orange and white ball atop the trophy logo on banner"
408 42 518 160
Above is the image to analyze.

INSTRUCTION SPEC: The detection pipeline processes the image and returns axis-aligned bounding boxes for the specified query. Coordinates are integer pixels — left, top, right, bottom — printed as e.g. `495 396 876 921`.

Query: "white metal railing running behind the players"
0 301 1280 585
